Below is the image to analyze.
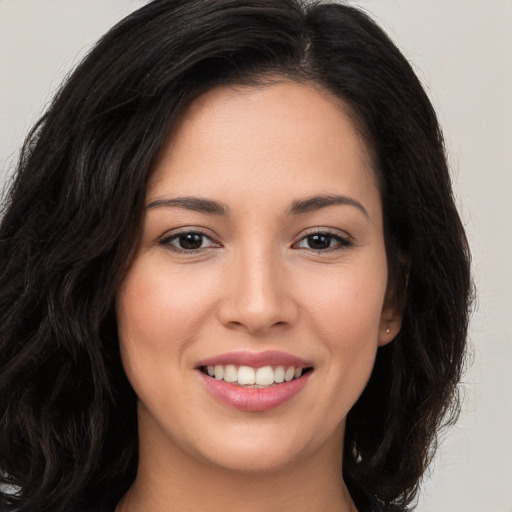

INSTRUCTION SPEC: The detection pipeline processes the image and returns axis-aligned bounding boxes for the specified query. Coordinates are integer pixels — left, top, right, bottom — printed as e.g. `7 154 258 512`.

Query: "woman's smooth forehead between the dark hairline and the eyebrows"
148 81 377 214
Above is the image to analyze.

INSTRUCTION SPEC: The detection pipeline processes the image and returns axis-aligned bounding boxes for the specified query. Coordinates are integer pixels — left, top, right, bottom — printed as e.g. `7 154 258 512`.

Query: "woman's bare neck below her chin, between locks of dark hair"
116 422 357 512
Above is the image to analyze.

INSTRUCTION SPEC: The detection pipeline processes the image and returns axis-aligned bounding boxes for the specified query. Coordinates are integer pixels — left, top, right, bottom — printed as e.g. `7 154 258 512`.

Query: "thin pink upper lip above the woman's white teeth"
197 350 313 368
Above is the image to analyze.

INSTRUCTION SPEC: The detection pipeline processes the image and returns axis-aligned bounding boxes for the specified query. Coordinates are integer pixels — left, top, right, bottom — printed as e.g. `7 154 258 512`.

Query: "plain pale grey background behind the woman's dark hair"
0 0 512 512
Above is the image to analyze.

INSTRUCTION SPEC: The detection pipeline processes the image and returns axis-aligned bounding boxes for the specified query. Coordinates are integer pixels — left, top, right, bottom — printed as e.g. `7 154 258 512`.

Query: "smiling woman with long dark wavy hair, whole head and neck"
0 0 470 512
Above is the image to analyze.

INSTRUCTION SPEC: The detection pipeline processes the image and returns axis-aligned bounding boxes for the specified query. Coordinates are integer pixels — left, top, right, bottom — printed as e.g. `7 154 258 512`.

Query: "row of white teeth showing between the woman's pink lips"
199 364 313 388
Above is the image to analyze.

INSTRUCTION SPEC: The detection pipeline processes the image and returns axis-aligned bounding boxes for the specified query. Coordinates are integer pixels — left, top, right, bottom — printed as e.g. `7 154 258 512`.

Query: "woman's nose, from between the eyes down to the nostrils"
218 245 298 335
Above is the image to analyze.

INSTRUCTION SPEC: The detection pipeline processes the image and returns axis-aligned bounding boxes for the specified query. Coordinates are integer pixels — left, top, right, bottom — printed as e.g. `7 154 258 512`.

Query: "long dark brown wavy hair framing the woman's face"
0 0 471 512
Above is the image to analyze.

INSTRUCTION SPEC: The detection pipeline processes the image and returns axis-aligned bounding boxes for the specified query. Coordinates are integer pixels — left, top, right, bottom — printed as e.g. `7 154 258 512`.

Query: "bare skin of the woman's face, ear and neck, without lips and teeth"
117 81 401 512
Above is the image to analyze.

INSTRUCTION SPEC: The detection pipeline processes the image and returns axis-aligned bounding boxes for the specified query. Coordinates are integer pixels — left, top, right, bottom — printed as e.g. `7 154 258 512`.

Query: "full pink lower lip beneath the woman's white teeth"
199 371 312 412
